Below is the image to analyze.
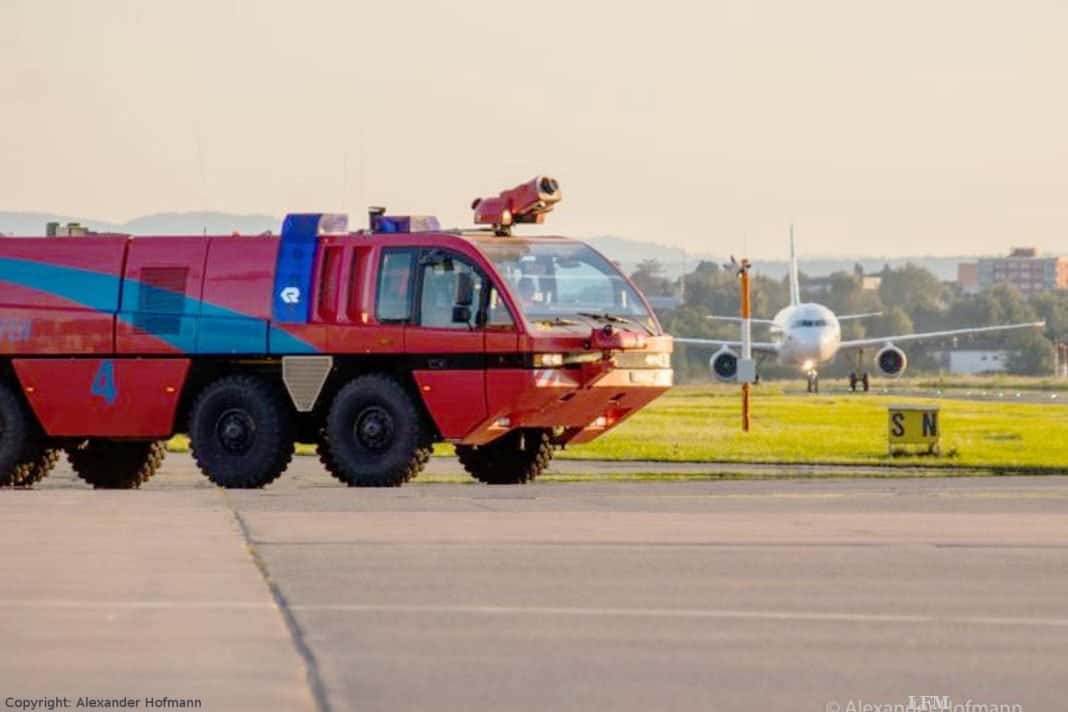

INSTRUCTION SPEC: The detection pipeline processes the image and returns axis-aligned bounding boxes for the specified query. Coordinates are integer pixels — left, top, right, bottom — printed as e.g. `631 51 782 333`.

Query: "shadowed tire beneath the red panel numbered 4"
67 440 167 490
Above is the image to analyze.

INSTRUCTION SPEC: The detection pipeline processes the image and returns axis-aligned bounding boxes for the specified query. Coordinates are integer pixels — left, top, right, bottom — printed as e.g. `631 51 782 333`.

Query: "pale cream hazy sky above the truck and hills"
0 0 1068 257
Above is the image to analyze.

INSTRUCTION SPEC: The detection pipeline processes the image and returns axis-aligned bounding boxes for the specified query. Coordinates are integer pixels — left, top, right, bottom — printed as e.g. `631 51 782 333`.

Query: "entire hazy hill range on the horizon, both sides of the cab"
0 211 991 281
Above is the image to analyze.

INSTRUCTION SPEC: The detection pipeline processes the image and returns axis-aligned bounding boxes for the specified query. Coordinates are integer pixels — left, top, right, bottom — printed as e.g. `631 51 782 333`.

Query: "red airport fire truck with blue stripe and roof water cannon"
0 177 672 488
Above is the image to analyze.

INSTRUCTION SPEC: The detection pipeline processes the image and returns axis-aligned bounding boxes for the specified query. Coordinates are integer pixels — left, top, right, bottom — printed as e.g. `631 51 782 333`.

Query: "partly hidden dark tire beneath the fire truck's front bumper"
456 430 552 485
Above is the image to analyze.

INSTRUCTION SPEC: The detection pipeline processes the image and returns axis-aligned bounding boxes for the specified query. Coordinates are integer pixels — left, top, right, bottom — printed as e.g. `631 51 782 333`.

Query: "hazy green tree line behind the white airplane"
630 259 1068 380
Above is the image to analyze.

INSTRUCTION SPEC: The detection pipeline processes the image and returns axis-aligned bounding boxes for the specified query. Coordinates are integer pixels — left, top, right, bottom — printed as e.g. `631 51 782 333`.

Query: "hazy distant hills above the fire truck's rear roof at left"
0 212 282 236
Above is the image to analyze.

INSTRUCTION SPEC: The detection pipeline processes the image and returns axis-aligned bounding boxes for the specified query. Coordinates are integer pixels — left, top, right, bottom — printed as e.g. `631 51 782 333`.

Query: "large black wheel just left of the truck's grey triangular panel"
189 375 296 489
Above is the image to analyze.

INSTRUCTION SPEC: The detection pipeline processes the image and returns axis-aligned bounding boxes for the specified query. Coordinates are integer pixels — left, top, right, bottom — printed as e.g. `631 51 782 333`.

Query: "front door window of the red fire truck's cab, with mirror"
419 251 483 329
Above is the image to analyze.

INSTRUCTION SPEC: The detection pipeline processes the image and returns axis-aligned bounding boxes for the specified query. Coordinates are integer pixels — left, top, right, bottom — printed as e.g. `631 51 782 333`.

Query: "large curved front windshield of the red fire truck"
480 239 656 333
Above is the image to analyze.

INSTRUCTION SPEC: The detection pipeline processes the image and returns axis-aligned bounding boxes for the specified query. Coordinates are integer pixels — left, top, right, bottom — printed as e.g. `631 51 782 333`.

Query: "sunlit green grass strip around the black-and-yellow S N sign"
562 386 1068 471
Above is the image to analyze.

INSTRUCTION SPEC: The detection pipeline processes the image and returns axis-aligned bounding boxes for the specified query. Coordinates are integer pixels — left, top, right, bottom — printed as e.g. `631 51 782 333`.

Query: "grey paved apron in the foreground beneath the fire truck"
0 456 1068 712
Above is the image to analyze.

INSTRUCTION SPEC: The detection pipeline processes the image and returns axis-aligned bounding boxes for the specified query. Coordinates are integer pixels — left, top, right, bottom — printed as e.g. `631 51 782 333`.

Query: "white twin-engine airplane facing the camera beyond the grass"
675 232 1046 393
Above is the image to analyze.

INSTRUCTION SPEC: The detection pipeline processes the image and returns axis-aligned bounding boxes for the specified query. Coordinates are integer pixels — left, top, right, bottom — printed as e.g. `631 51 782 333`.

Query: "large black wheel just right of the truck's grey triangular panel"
319 374 430 487
